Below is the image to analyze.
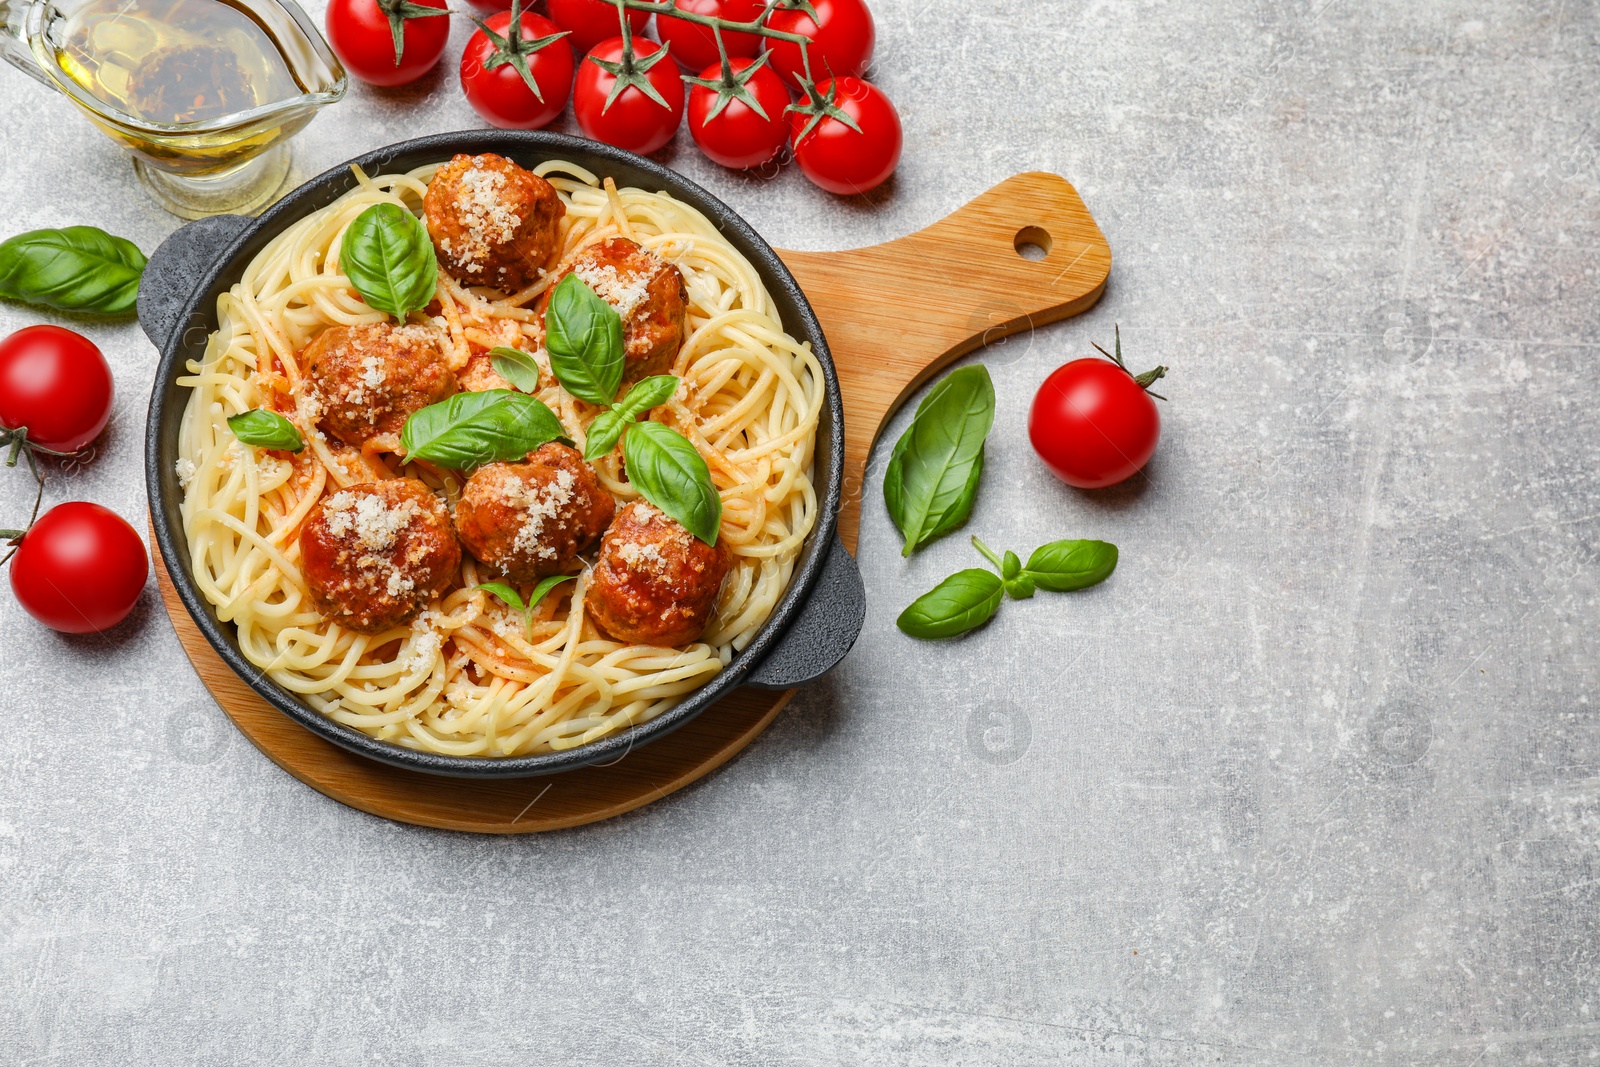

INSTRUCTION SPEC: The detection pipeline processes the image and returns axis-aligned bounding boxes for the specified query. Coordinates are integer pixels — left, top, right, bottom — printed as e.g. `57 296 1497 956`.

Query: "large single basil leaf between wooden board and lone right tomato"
883 365 995 555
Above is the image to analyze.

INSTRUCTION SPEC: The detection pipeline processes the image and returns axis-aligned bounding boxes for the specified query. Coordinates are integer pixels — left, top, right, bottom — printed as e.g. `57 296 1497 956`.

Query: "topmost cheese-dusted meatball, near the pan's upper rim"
422 155 566 293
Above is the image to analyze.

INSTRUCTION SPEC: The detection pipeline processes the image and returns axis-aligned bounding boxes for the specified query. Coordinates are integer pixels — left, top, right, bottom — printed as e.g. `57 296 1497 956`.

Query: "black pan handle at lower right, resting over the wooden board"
746 533 867 689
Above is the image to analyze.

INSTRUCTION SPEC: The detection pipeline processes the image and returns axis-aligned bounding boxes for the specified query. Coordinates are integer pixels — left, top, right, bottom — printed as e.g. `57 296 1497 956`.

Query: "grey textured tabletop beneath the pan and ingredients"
0 0 1600 1067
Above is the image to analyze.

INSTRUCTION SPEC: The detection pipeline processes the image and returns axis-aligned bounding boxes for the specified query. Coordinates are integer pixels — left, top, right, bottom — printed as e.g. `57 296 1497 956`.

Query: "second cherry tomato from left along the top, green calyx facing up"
461 11 573 130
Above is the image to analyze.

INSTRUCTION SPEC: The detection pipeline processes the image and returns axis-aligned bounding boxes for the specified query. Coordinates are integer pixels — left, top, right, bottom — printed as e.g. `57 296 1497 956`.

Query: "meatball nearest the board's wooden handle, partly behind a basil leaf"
550 237 690 384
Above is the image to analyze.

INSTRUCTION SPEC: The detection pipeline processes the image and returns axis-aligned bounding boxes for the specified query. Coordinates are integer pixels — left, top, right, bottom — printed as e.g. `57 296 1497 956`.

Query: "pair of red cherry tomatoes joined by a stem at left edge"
0 326 149 633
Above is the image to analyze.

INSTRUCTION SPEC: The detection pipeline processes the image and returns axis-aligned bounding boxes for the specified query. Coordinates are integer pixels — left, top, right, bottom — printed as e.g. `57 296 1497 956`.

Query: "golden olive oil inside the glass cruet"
56 0 306 125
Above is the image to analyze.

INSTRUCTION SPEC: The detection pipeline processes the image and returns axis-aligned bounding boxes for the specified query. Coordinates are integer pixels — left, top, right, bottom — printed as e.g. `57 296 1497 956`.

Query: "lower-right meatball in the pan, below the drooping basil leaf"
587 501 733 646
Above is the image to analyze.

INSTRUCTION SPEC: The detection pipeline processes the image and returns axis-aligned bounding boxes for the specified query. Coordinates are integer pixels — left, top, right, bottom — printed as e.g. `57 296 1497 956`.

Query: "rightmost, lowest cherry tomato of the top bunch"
789 78 902 197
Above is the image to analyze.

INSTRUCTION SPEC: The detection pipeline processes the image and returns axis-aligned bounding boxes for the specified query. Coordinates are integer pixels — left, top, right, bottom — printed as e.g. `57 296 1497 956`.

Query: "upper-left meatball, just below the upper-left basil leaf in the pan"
299 323 456 448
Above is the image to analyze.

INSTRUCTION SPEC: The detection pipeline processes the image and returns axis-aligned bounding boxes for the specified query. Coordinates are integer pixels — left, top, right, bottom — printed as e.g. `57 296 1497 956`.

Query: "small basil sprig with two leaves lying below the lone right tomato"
894 537 1117 640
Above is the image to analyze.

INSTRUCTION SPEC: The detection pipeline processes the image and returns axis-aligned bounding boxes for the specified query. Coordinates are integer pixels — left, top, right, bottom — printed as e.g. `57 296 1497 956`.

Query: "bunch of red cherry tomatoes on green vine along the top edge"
326 0 902 195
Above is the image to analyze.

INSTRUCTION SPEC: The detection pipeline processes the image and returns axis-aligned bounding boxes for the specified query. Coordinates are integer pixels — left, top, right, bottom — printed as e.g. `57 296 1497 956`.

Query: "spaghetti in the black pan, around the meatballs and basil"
178 162 824 757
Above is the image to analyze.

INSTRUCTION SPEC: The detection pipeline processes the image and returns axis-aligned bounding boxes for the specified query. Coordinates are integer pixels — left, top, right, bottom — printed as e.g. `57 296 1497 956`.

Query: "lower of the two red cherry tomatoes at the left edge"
11 501 150 633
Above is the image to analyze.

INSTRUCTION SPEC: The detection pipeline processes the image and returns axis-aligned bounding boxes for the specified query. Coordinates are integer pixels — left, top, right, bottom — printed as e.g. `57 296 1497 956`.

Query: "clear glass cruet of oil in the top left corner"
0 0 347 219
